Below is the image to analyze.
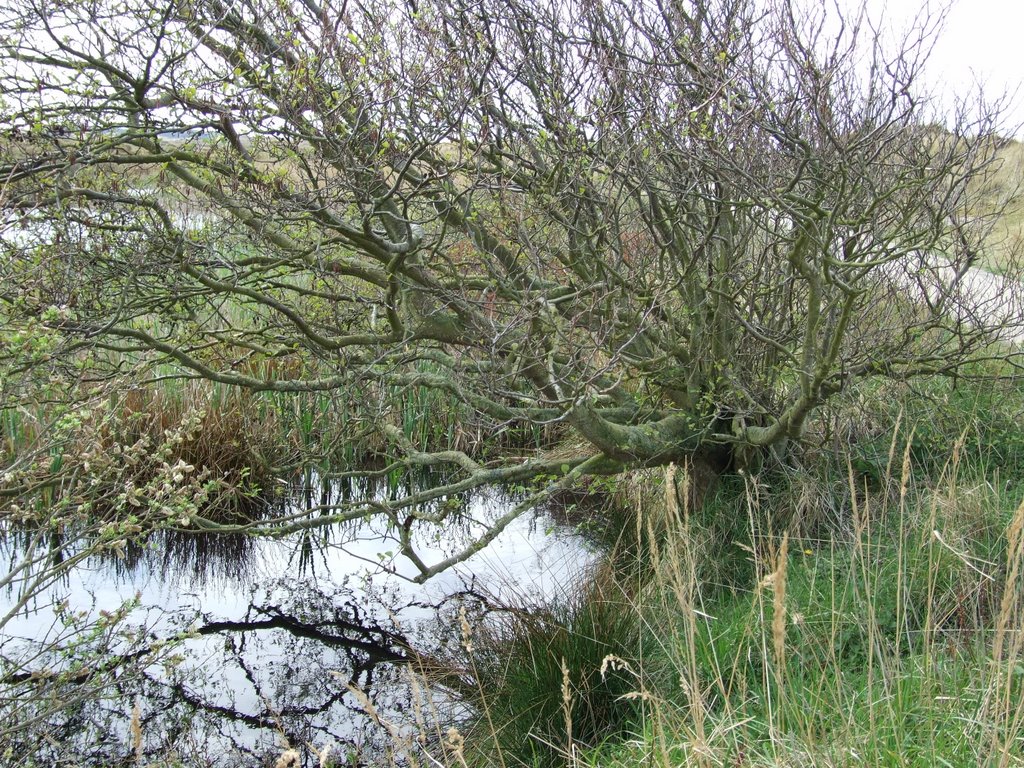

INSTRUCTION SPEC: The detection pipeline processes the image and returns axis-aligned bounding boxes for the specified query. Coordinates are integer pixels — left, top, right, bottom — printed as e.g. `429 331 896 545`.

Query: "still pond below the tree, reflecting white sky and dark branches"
0 475 596 766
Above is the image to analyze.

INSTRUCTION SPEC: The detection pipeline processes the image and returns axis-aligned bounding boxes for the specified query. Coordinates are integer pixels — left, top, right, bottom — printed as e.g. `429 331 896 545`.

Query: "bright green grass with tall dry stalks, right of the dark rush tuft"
579 460 1024 766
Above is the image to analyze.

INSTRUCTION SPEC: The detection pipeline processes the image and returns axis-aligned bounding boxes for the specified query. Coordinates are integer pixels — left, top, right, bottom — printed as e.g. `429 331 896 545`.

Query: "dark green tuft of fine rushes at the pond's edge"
452 570 640 768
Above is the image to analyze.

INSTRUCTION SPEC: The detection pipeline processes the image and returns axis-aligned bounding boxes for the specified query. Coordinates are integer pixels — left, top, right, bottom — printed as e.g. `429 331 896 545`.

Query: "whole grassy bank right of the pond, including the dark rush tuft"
391 383 1024 768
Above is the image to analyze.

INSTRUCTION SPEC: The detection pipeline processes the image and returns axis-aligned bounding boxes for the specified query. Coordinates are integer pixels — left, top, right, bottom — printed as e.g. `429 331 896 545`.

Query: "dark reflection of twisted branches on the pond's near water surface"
0 580 425 765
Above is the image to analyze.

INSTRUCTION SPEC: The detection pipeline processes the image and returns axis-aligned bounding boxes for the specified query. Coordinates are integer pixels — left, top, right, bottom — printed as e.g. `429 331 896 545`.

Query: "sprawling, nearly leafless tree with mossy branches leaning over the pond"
0 0 1019 580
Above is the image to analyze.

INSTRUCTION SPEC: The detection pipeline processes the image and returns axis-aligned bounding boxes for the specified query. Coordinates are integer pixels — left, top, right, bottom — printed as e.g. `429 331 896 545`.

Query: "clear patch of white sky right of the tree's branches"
867 0 1024 138
